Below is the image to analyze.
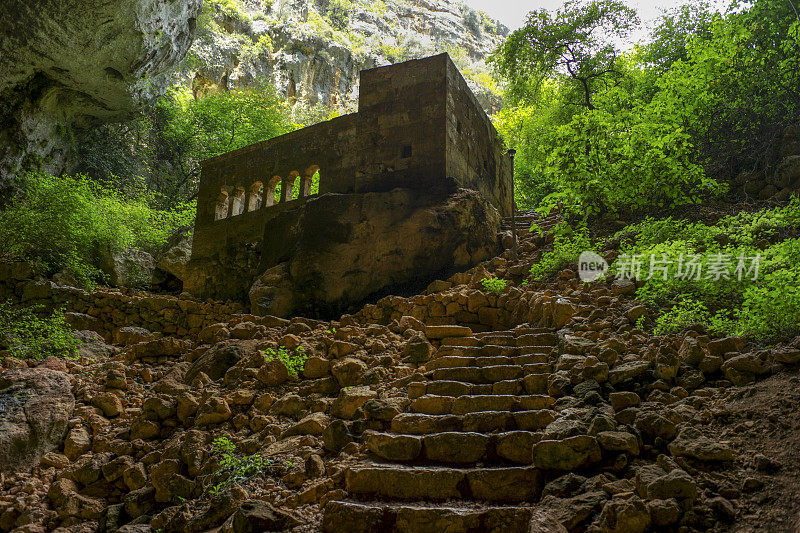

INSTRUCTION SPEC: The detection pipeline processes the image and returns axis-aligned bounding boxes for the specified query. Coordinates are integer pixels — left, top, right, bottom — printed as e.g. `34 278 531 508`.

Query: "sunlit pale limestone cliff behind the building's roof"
181 0 508 113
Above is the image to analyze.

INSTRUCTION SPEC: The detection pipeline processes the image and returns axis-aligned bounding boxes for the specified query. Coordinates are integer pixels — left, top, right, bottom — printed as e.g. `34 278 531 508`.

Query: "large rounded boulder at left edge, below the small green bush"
0 368 75 473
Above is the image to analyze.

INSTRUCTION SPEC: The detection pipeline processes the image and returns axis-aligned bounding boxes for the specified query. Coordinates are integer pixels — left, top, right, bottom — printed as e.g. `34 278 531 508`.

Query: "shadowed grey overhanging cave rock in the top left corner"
0 0 200 195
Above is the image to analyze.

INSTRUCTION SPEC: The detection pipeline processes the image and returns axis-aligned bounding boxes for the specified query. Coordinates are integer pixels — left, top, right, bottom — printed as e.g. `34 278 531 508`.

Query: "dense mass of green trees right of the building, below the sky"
492 0 800 215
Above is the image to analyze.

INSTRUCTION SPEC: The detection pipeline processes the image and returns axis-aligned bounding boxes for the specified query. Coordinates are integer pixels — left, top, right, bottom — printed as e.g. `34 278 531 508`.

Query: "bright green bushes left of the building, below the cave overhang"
0 174 195 285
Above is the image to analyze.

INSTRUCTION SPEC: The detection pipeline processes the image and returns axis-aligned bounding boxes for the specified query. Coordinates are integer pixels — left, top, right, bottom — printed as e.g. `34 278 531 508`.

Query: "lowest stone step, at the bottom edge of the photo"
322 500 533 533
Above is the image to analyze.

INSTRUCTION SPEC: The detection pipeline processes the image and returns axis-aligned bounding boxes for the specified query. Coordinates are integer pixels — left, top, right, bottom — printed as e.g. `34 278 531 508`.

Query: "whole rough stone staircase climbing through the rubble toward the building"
322 326 557 533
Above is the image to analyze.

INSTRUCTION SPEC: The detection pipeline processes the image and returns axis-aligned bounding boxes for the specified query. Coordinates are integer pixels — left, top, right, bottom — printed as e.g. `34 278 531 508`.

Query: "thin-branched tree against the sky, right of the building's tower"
490 0 639 110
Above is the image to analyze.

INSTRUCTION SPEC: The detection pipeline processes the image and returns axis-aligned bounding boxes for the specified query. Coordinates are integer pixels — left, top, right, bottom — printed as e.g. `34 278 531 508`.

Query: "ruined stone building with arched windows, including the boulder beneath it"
183 54 512 315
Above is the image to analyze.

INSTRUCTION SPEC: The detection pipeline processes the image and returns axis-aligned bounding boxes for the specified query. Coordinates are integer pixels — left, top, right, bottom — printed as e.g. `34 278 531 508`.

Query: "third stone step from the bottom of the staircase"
364 430 541 465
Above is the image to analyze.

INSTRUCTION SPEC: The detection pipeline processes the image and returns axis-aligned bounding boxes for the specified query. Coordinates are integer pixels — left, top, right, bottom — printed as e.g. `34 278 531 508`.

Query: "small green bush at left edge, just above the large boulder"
0 301 80 360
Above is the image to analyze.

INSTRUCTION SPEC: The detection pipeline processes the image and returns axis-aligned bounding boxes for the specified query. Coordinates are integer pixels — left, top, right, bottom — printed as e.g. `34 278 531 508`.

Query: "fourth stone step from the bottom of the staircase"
391 409 556 435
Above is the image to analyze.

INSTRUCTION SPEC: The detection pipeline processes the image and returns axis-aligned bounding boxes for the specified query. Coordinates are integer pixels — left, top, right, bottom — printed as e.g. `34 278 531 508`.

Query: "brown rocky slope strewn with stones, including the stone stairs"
0 221 800 532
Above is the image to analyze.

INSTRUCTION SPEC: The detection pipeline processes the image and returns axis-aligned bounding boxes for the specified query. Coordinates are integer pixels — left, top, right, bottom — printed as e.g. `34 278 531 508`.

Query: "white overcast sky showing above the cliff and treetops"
461 0 728 40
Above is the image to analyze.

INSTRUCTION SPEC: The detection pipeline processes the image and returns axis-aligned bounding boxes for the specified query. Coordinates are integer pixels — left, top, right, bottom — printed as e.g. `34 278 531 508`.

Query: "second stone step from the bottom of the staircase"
345 464 542 503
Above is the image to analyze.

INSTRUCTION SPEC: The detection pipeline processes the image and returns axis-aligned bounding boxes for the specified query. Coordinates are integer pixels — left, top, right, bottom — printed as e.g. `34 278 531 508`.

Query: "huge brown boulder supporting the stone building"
245 189 500 316
